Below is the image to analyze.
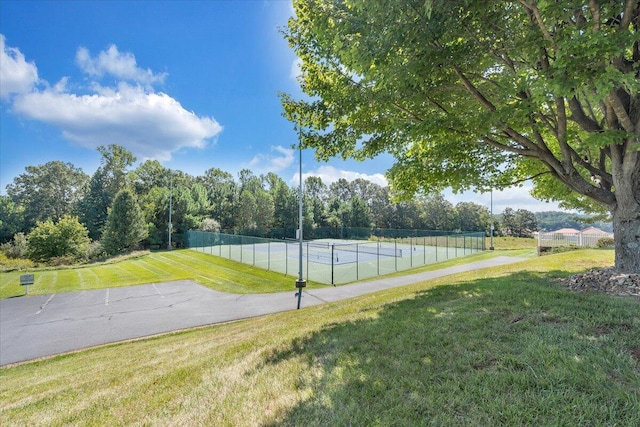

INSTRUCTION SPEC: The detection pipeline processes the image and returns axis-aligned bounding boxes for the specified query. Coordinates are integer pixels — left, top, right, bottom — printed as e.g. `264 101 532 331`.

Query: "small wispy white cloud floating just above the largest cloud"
76 45 167 85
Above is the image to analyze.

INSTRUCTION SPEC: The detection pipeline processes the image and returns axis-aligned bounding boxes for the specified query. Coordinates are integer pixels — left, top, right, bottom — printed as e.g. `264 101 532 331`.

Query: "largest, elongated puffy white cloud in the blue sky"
14 79 222 161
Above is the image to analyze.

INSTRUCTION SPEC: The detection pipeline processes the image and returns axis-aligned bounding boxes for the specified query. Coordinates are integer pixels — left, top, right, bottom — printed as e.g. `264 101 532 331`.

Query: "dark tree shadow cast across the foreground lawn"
264 272 640 426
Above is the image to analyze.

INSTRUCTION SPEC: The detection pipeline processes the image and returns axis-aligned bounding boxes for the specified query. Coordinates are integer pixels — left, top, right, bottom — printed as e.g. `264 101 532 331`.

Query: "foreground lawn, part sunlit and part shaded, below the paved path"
0 250 640 426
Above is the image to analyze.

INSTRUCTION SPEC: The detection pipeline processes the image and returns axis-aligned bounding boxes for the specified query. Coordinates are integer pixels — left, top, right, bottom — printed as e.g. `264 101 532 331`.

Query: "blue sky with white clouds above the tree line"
0 0 557 212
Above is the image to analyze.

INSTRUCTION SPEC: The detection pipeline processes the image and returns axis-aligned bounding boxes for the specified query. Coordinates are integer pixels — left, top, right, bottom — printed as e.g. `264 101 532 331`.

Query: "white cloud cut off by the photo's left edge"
0 34 38 99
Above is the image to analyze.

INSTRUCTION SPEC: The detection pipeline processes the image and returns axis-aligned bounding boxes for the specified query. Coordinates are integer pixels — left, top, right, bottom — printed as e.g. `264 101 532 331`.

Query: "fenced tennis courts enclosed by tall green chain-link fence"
185 230 485 285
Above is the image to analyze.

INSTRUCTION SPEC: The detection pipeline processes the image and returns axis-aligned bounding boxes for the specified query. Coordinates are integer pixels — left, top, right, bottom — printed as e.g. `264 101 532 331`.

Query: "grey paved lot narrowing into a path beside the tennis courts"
0 257 522 365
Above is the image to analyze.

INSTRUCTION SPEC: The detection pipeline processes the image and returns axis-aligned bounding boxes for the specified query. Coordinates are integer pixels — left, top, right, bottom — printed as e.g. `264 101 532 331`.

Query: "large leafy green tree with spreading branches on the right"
282 0 640 272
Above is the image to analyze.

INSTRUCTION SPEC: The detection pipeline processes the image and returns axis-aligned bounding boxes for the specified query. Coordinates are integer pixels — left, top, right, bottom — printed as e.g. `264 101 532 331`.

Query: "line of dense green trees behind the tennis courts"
0 145 537 261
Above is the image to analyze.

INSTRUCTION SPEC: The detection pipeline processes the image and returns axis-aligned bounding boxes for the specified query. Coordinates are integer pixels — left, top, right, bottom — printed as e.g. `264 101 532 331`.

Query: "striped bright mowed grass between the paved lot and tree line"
0 250 308 298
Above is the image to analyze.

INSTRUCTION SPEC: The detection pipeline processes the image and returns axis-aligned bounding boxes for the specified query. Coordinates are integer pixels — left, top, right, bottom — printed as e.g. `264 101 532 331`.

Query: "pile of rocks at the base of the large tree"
559 268 640 302
